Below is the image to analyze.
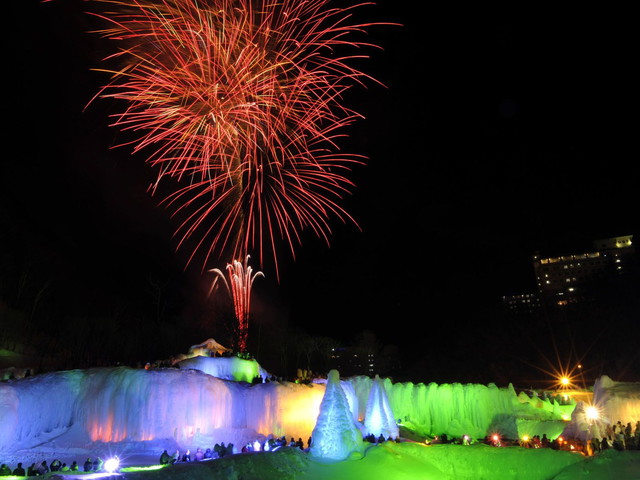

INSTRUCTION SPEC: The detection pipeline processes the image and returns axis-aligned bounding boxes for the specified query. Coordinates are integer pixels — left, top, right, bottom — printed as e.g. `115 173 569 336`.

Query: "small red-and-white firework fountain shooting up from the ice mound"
210 255 264 352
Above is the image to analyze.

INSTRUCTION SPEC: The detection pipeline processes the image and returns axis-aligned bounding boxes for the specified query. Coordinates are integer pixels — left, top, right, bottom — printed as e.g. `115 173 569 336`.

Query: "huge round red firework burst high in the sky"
87 0 382 269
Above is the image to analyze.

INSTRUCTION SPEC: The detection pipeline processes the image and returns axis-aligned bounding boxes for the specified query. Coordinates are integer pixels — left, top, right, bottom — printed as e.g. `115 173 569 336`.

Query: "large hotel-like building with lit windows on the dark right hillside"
533 235 636 306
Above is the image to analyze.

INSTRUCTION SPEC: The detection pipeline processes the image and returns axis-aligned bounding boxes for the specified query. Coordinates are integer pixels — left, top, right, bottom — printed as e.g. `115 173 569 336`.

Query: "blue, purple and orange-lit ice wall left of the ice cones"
0 367 325 450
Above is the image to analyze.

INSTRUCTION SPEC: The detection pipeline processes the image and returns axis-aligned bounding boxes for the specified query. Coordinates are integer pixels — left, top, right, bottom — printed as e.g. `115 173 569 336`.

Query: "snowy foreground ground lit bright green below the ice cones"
2 442 640 480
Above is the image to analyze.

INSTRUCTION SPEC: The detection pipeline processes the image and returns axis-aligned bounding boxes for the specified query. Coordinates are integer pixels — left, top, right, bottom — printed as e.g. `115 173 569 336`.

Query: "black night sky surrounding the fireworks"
0 0 640 382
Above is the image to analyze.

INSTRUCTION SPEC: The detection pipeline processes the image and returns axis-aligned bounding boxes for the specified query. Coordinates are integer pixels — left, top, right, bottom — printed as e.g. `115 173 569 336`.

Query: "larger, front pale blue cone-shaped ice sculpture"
310 370 362 460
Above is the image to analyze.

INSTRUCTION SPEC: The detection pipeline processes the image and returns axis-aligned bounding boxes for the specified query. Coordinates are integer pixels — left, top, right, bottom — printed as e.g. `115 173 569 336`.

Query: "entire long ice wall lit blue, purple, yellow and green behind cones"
0 366 580 451
